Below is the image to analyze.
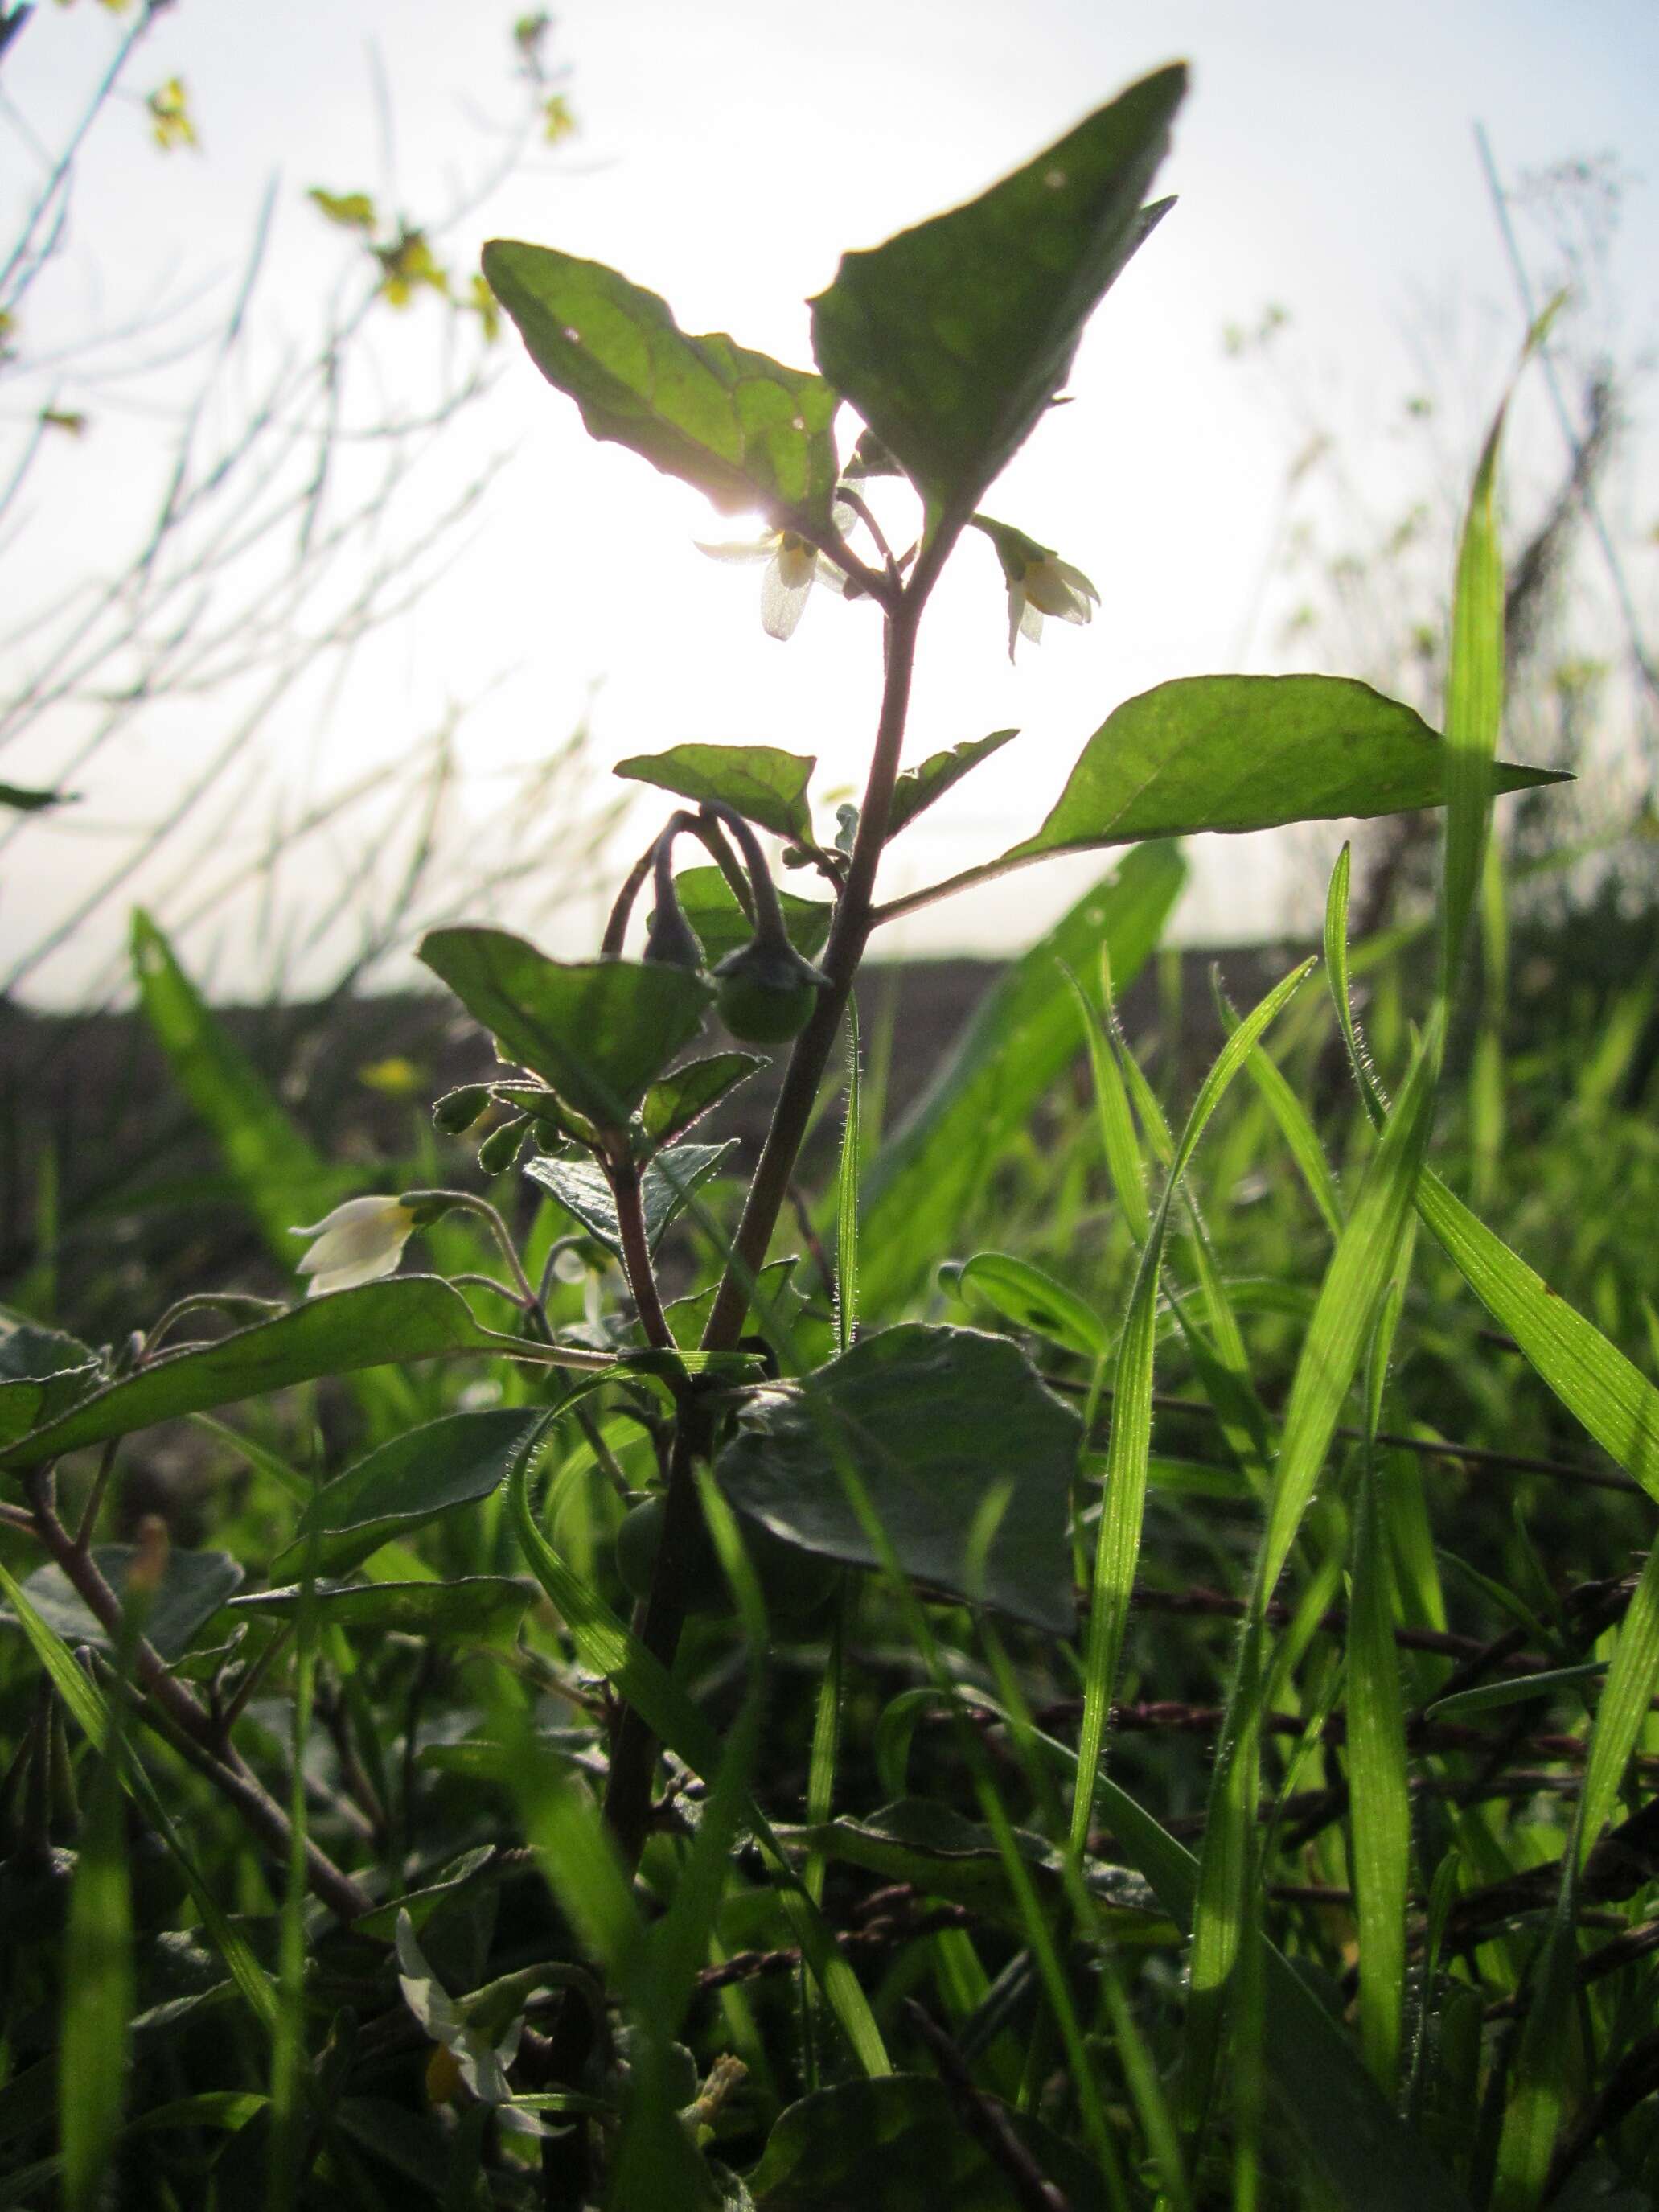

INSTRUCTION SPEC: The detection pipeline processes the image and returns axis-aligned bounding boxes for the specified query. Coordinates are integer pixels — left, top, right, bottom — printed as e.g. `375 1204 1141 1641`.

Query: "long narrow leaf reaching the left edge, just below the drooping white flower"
0 1274 500 1466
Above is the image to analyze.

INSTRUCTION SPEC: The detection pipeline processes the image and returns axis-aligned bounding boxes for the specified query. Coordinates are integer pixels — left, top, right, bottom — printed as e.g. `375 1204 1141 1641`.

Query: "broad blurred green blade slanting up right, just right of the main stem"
860 845 1185 1316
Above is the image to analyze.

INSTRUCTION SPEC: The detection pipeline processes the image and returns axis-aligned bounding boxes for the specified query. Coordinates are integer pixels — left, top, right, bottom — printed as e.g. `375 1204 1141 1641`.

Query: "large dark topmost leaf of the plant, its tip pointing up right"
811 67 1185 516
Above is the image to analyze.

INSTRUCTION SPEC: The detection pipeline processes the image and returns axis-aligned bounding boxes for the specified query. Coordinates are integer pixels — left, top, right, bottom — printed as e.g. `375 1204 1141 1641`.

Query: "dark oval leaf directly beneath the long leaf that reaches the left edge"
272 1407 546 1575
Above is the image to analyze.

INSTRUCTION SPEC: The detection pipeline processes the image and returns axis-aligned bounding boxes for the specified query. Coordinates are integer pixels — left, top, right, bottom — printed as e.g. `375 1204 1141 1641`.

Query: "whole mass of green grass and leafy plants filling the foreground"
0 64 1659 2212
